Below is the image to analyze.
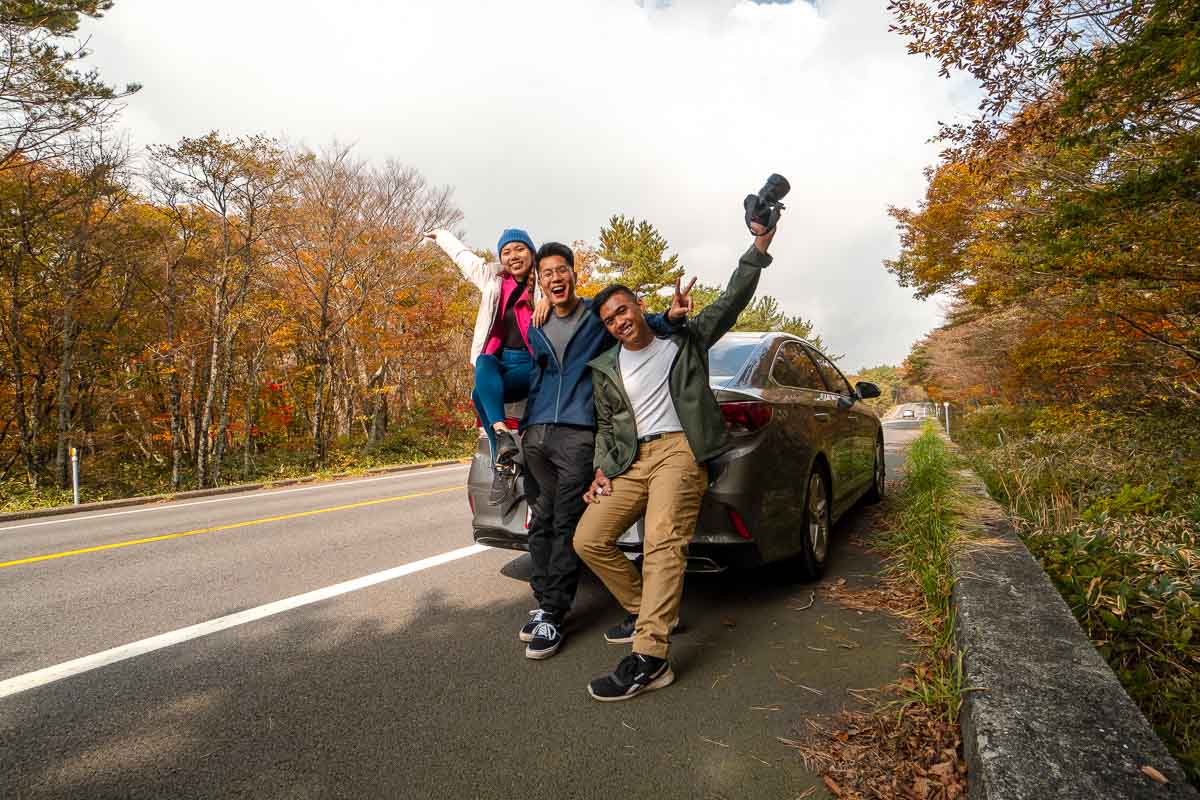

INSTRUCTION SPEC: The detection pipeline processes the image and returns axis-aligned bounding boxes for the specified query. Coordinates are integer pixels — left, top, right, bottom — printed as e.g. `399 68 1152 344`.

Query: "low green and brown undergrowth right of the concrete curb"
958 407 1200 781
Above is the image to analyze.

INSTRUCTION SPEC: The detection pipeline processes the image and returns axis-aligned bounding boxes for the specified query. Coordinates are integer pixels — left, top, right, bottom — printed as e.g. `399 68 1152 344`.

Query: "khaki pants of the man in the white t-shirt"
575 433 708 658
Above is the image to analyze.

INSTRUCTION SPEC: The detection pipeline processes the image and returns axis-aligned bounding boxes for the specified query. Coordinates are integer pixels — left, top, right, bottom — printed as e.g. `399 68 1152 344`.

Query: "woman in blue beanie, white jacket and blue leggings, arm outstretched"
425 228 548 505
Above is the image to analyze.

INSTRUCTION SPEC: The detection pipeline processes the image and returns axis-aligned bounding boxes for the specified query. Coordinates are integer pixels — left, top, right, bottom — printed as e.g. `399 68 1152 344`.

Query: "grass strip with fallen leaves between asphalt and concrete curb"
791 423 966 800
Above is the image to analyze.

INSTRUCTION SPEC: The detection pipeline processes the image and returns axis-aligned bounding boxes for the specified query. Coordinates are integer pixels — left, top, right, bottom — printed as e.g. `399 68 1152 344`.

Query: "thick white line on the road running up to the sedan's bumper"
0 545 491 699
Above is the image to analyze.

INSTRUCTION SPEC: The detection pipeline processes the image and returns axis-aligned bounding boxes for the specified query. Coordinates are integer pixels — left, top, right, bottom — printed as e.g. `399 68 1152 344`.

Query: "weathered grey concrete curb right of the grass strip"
954 471 1200 800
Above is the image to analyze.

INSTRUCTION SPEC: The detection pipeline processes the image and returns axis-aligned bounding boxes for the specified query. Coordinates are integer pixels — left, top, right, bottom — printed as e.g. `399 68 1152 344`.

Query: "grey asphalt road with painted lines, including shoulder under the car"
0 425 916 800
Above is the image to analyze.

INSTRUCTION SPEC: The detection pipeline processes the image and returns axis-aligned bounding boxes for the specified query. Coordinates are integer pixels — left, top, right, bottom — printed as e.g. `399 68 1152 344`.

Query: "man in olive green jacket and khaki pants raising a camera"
575 223 775 702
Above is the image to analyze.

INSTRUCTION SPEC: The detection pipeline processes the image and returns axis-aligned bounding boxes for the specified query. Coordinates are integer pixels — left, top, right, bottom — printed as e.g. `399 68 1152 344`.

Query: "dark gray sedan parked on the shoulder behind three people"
467 332 884 578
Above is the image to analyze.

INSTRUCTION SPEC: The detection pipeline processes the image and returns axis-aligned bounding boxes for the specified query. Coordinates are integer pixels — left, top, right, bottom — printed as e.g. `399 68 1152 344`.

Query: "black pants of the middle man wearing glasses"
521 425 595 619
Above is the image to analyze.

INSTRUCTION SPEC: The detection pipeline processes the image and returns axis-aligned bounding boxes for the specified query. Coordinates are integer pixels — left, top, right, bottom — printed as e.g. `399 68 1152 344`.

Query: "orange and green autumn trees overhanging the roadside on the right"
888 0 1200 405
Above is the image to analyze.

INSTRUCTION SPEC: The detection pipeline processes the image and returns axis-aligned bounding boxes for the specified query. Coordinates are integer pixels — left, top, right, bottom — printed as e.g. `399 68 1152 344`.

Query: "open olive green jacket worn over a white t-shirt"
588 245 772 477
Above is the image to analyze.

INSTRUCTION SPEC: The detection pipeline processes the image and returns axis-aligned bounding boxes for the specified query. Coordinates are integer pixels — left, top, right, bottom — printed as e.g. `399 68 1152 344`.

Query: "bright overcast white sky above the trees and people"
77 0 974 369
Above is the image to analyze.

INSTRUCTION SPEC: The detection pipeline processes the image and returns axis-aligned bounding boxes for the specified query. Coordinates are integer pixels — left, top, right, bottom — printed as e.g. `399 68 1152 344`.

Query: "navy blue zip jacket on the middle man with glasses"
521 297 682 431
